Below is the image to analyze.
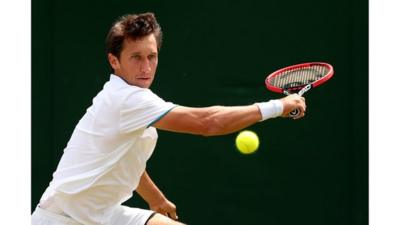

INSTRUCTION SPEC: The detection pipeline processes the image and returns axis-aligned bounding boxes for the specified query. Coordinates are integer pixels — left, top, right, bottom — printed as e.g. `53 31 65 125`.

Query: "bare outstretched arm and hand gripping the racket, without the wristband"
153 94 306 136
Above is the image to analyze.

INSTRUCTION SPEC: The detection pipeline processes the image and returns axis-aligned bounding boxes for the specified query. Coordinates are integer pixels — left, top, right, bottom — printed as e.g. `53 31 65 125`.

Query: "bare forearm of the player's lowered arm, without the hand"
136 171 166 205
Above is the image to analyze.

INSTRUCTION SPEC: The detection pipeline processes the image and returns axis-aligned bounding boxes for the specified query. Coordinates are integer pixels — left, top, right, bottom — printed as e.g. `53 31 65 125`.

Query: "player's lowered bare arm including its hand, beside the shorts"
136 171 178 220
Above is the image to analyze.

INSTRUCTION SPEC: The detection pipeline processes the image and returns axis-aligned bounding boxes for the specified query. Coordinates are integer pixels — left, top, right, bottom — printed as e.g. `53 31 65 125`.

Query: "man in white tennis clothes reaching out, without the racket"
32 13 306 225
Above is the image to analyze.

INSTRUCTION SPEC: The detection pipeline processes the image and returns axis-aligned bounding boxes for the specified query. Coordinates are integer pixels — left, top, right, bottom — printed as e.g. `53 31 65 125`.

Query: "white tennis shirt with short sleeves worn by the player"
40 74 175 224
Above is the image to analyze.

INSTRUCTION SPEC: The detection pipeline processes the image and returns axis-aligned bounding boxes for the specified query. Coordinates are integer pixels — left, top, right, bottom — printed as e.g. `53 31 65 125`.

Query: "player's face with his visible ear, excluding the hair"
108 34 158 88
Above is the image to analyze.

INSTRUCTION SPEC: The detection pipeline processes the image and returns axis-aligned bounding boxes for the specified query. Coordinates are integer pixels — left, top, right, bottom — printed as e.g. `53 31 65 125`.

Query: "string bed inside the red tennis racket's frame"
271 65 328 89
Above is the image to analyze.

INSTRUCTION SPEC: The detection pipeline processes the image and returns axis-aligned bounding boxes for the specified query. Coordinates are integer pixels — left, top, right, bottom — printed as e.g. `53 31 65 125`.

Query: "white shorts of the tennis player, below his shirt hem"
31 205 155 225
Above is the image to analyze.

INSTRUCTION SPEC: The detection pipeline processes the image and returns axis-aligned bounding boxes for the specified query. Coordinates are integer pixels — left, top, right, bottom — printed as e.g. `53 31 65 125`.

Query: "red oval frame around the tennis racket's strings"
265 62 334 93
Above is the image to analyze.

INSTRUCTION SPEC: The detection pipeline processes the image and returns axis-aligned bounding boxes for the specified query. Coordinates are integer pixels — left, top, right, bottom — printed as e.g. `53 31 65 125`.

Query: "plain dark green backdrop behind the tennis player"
31 0 368 225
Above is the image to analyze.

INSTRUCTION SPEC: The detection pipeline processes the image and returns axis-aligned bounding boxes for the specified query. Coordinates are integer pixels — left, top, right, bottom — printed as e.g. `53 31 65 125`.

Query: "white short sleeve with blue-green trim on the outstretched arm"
119 89 175 133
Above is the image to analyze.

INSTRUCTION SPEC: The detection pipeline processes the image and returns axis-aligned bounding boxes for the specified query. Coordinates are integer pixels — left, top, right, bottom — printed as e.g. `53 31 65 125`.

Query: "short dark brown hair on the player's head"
106 12 162 58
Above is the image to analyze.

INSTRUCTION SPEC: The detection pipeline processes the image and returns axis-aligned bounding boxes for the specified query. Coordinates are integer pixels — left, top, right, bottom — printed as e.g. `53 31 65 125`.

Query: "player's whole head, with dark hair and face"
106 13 162 88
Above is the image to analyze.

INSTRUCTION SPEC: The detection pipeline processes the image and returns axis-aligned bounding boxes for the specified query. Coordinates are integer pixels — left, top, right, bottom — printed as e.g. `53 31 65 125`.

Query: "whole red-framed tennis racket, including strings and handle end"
265 62 333 117
